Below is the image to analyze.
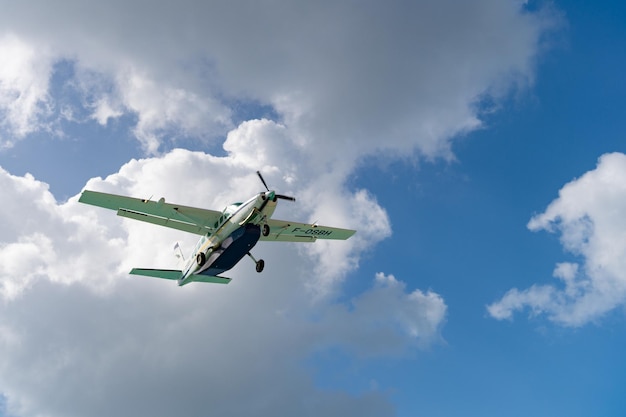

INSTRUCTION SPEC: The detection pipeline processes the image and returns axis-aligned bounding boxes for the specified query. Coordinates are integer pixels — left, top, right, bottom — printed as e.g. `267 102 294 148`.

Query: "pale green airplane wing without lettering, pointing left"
78 190 222 235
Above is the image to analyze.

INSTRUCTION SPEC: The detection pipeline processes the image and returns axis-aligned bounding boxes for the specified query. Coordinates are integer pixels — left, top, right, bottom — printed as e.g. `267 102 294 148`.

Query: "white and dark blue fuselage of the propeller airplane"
178 191 276 286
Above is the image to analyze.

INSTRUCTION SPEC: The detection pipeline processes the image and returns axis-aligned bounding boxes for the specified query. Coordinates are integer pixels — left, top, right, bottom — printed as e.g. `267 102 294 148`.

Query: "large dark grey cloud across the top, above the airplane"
0 0 553 157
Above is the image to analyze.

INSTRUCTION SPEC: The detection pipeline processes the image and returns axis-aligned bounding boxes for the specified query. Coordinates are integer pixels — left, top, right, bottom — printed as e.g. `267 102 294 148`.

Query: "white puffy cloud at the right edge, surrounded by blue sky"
488 153 626 326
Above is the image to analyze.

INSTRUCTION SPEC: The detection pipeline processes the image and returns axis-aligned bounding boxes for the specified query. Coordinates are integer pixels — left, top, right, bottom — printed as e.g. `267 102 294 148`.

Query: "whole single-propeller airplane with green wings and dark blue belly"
78 171 356 286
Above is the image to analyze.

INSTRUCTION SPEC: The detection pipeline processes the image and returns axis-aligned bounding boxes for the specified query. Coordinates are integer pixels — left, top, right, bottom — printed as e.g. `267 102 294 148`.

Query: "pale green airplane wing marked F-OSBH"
260 219 356 242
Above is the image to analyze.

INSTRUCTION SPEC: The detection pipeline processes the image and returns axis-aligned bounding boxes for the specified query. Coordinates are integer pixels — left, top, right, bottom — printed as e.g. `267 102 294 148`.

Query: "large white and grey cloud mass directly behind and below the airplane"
0 148 446 416
